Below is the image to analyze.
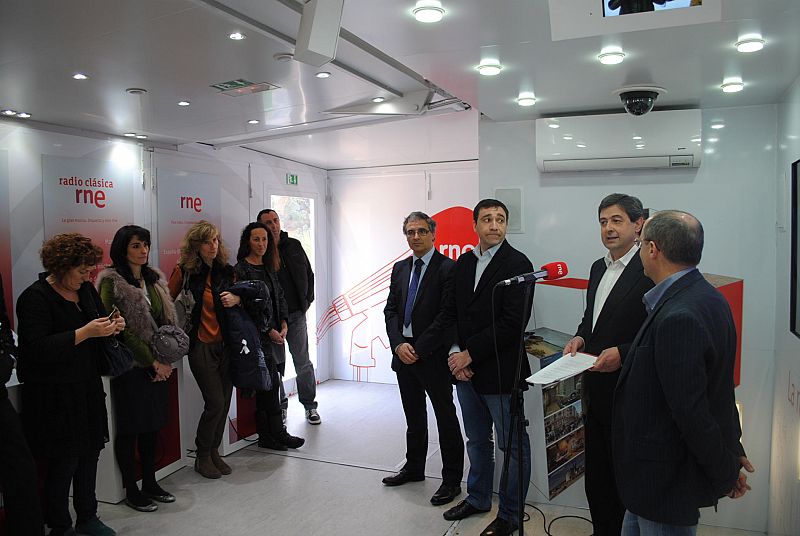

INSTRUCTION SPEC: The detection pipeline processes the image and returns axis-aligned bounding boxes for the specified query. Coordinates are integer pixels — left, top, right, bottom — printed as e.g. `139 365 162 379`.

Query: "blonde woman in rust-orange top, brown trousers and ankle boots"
169 220 241 478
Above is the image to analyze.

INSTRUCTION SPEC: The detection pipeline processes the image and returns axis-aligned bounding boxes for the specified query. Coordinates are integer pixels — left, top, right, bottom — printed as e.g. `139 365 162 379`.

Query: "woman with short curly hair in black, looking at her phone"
17 233 125 536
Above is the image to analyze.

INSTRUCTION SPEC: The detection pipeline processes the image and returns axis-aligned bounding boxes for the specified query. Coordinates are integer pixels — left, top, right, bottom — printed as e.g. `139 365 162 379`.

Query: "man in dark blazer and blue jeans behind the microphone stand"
443 199 533 536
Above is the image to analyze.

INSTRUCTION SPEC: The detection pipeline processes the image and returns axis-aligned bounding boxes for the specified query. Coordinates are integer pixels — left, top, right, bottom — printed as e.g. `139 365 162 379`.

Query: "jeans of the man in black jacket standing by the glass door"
272 311 317 410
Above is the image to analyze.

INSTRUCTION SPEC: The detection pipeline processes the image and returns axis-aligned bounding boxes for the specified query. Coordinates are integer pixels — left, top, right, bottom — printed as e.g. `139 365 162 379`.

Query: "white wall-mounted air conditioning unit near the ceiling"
536 110 703 173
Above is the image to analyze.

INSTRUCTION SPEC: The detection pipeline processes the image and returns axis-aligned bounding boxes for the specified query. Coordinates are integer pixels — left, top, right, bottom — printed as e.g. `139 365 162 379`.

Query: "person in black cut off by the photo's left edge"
0 278 44 536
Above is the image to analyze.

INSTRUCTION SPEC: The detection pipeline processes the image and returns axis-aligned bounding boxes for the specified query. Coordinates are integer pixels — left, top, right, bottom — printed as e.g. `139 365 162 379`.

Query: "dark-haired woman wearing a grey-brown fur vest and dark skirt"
97 225 176 512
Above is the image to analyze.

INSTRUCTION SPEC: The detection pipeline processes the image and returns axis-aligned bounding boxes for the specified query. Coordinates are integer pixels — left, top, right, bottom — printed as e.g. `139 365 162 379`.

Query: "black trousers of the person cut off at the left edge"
0 396 44 536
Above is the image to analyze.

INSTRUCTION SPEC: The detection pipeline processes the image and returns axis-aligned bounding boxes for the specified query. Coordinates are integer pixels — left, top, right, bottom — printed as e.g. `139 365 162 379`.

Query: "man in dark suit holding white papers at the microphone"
564 194 653 536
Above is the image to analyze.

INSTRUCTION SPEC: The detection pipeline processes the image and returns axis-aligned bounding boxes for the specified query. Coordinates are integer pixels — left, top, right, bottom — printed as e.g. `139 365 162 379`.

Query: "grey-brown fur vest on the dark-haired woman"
97 266 178 341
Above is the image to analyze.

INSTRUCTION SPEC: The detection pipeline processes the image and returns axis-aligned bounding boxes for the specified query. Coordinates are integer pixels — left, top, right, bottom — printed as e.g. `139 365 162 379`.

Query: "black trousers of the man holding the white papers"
584 410 625 536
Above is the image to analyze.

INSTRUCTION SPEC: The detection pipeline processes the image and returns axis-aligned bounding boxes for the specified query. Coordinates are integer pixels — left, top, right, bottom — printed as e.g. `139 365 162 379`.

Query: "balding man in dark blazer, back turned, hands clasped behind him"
613 210 753 536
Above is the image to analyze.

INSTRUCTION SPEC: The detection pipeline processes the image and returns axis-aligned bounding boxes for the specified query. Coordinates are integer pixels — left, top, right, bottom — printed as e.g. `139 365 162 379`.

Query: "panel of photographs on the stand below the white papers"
542 374 586 499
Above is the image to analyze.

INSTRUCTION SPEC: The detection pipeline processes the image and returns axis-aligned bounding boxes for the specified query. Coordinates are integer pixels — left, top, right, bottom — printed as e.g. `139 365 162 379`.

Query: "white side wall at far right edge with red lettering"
769 73 800 536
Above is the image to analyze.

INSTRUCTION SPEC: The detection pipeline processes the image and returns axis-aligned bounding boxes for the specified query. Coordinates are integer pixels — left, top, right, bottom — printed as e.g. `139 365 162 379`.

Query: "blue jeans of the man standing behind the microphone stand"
456 382 531 525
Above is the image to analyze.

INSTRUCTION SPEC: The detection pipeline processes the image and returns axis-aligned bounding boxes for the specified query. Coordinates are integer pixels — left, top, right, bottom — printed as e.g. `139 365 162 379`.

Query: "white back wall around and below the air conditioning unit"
480 106 780 530
